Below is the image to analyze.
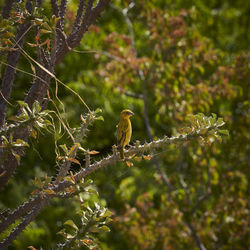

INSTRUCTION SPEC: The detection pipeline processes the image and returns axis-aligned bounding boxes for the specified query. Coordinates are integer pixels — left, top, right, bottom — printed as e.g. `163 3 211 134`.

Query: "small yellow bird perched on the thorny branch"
117 109 134 160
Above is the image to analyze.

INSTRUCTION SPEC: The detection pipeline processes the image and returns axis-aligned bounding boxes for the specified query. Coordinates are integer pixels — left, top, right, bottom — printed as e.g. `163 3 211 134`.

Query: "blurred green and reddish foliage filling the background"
0 0 250 249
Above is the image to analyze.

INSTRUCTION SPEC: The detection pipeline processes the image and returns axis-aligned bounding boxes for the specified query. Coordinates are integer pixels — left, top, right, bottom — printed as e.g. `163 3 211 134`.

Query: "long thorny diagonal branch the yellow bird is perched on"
0 122 223 237
